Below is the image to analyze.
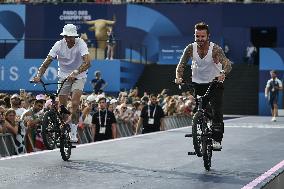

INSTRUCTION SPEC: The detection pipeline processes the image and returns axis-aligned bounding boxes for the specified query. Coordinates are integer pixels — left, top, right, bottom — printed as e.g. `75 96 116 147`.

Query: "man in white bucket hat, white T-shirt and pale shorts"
33 24 91 142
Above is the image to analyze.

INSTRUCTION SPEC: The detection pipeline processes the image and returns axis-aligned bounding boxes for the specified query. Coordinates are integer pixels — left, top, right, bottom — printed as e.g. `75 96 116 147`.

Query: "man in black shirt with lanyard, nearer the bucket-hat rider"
92 97 116 141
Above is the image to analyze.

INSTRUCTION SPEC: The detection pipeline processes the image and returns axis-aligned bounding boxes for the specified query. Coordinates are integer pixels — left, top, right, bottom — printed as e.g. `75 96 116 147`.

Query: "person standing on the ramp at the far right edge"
265 70 283 121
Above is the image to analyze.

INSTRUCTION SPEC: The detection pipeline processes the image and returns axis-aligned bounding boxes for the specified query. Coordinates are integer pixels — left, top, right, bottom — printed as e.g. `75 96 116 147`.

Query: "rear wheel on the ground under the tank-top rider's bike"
202 135 213 171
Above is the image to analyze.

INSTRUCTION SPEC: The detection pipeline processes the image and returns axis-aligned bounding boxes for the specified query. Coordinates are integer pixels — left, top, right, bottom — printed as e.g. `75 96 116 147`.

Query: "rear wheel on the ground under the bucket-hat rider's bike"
60 124 72 161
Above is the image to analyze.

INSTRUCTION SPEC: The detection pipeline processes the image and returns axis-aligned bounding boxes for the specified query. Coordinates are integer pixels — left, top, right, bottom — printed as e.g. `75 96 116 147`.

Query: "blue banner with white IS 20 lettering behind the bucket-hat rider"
0 59 144 93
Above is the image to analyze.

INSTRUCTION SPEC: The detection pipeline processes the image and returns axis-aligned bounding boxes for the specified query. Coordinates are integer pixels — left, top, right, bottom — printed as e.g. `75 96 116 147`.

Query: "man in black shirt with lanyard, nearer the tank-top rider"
135 94 165 134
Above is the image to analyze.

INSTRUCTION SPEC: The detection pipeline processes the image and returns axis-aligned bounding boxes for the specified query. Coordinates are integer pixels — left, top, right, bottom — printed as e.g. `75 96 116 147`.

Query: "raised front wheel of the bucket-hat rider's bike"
41 110 59 150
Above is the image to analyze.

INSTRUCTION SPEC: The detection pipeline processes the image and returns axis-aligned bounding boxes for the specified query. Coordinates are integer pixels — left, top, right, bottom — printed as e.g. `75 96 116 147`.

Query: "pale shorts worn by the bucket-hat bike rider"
57 78 87 95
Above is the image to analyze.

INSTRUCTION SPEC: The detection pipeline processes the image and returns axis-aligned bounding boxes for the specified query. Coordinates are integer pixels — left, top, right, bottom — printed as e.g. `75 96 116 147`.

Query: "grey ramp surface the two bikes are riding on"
0 117 284 189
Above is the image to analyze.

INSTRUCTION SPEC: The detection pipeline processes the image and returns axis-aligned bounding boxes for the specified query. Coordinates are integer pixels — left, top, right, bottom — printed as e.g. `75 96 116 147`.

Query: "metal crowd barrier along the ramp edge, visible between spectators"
0 116 192 157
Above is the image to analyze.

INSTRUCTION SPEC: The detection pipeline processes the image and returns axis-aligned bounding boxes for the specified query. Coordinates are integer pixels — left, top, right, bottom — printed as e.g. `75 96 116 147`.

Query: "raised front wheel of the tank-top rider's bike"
192 112 204 157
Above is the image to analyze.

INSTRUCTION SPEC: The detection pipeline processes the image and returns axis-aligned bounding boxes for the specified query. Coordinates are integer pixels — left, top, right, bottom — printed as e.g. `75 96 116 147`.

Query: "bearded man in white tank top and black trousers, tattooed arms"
176 22 232 150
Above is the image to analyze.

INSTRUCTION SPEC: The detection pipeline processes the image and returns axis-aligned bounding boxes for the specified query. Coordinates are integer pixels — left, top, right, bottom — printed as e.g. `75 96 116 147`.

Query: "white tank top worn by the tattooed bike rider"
191 42 222 83
